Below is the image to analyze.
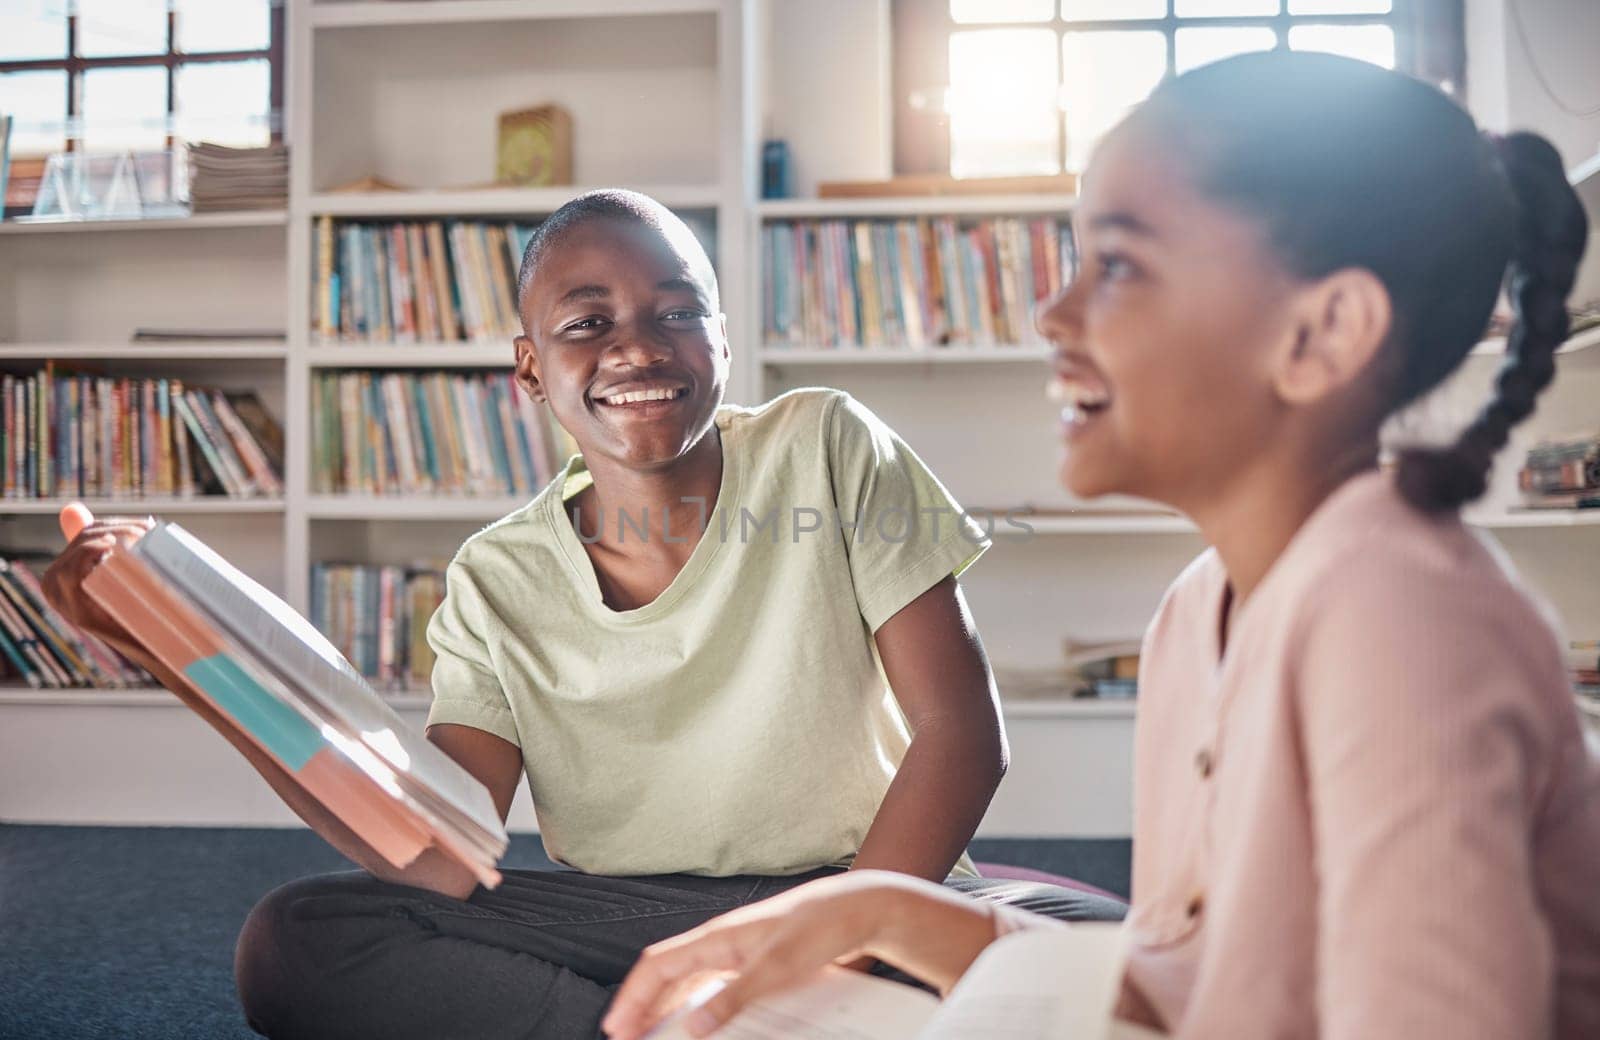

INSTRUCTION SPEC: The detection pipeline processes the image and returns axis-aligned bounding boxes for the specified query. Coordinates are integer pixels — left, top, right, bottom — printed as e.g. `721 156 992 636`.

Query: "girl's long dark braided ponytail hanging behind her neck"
1397 133 1589 512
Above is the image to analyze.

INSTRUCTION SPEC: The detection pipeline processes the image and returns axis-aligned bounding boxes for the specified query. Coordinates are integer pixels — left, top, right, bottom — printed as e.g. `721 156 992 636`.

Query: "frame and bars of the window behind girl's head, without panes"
890 0 1466 176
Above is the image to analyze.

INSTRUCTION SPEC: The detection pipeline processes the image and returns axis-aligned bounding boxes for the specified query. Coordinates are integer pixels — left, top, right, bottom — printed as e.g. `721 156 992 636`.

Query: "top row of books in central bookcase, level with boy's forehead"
310 214 717 344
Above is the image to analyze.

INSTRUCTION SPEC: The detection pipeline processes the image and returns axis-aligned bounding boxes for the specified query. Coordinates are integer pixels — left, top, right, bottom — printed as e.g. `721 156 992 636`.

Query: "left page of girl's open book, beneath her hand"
646 968 939 1040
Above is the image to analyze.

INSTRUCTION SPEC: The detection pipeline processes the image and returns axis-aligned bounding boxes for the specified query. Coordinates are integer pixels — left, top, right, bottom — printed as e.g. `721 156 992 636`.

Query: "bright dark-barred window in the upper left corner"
0 0 285 155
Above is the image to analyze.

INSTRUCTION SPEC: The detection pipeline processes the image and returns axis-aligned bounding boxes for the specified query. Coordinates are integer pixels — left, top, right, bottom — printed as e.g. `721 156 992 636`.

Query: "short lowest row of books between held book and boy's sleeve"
310 563 445 690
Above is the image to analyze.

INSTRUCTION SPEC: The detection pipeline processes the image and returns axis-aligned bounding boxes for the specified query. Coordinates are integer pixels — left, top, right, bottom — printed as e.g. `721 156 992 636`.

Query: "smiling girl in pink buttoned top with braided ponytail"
606 53 1600 1040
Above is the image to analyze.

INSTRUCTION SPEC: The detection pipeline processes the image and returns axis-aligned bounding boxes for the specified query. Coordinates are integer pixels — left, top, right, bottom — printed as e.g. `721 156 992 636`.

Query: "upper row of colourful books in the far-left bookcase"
0 363 283 498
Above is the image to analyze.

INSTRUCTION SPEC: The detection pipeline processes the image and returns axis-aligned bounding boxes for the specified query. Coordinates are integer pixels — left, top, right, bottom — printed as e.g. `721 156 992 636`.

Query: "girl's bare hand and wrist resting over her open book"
602 870 994 1040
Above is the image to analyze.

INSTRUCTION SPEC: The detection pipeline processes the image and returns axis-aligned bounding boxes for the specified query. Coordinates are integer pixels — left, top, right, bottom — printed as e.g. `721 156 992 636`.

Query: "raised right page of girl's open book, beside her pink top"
917 923 1126 1040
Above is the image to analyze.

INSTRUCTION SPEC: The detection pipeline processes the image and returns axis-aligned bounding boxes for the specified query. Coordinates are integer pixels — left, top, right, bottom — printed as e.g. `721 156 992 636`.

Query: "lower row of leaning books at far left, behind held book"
0 558 152 690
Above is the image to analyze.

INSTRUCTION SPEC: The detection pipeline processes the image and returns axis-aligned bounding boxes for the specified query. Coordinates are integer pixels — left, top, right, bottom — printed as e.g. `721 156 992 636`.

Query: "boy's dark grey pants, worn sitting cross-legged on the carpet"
234 867 1125 1040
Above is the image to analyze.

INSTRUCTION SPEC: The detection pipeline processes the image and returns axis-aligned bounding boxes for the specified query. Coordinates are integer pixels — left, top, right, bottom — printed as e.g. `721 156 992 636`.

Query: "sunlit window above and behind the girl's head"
894 0 1464 178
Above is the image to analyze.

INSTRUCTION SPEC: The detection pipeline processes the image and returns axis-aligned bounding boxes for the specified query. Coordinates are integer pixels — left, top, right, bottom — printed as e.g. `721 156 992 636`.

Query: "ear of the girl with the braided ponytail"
1274 267 1394 405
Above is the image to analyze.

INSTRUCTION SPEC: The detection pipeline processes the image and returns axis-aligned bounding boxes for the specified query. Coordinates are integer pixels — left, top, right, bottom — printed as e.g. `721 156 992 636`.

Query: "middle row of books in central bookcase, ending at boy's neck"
310 370 578 494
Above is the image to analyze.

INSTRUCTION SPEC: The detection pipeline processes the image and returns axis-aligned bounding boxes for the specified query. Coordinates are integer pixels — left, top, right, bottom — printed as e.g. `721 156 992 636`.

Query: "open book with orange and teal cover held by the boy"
83 522 507 888
